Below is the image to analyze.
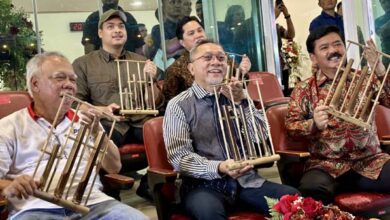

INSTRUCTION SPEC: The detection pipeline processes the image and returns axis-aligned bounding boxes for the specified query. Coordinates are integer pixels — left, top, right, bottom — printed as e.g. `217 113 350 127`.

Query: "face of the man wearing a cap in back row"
98 17 127 48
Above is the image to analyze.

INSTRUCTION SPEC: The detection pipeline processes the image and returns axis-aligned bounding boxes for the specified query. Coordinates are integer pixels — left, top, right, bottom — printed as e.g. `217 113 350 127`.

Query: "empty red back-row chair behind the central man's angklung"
248 72 290 109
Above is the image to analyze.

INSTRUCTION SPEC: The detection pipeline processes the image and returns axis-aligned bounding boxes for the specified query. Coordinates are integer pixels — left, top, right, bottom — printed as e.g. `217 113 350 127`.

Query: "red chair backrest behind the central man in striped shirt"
143 116 173 170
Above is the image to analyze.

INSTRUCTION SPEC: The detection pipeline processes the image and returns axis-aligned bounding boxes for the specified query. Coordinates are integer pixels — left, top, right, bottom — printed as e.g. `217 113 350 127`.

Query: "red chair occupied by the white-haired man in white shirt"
0 91 134 219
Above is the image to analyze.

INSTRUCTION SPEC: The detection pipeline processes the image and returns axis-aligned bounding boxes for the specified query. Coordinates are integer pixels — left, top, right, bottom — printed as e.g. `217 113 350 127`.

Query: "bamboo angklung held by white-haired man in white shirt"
33 94 116 214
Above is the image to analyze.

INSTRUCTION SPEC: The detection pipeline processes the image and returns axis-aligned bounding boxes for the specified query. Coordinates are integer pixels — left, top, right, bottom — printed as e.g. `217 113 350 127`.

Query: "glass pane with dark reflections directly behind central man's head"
203 0 266 71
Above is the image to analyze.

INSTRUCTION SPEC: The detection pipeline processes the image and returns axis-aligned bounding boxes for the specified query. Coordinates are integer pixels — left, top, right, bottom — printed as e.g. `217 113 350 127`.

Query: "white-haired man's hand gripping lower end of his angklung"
2 175 39 199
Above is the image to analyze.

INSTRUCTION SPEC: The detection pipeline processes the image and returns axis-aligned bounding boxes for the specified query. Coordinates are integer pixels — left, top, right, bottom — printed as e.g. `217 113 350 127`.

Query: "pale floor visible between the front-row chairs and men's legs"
121 165 280 220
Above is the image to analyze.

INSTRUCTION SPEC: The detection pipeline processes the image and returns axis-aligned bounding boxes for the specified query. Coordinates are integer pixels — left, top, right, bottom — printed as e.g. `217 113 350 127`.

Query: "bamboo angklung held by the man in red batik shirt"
324 41 390 129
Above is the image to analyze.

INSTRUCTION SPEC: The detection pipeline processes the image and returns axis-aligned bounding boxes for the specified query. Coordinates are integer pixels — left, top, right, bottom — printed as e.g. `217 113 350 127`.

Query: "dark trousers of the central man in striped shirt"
182 177 299 220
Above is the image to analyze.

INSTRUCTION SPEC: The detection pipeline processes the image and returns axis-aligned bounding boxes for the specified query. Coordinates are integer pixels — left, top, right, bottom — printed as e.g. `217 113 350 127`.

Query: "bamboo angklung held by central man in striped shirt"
214 79 280 170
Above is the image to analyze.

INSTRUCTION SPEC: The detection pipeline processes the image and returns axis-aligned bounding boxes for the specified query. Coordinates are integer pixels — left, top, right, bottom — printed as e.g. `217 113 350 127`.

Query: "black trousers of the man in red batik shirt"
299 161 390 204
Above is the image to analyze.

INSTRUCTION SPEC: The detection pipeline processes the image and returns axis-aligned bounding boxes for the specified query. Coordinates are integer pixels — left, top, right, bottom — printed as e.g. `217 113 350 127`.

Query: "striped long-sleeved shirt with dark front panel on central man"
163 83 265 187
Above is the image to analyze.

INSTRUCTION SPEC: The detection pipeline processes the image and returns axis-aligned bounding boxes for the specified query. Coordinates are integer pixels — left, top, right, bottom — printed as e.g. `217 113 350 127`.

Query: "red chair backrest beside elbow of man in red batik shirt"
266 104 307 151
